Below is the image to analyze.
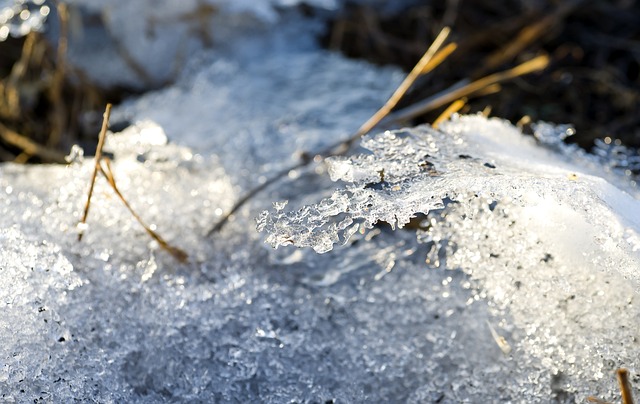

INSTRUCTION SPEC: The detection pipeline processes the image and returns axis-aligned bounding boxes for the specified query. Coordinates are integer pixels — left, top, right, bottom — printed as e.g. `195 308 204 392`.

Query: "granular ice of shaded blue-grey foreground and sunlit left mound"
0 117 546 403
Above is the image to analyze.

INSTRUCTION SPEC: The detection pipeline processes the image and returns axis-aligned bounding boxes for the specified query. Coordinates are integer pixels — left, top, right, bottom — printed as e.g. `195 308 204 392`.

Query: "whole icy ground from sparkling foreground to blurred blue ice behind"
0 3 640 403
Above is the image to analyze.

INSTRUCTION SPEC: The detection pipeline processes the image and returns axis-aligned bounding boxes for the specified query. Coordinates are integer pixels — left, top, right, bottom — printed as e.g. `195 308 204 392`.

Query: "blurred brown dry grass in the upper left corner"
0 3 120 163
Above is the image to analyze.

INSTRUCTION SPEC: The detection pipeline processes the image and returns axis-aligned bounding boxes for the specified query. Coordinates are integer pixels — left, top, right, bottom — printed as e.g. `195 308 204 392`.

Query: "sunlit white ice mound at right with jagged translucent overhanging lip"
258 116 640 402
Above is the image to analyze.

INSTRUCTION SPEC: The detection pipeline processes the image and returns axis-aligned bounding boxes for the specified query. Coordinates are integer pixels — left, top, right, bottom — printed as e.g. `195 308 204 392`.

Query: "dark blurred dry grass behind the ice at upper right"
323 0 640 152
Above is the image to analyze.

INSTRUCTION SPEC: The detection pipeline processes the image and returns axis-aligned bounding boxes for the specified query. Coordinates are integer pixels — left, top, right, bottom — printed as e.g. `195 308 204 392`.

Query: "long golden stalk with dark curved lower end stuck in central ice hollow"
206 27 456 237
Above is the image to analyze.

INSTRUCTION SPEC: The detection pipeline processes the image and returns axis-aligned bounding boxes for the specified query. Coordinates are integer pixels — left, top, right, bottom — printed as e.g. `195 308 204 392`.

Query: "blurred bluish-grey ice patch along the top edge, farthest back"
57 0 411 90
